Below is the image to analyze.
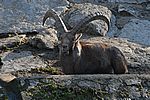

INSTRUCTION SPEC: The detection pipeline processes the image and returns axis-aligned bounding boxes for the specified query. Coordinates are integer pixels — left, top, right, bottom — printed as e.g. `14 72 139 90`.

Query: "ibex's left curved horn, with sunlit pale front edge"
43 9 68 32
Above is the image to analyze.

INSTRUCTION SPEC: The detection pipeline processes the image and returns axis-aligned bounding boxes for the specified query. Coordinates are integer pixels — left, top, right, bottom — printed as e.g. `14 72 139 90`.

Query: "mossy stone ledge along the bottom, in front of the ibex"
1 74 150 100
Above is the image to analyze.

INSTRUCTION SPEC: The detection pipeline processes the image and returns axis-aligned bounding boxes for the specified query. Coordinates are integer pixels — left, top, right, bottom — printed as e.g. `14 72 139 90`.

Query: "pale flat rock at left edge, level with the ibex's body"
0 50 46 73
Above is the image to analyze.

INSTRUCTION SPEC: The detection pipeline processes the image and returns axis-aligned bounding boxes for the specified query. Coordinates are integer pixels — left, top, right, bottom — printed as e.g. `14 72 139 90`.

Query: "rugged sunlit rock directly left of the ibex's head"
29 28 58 49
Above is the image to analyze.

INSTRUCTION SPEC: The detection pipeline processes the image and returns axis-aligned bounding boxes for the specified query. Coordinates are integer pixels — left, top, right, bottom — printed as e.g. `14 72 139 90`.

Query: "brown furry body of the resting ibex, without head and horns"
61 42 128 74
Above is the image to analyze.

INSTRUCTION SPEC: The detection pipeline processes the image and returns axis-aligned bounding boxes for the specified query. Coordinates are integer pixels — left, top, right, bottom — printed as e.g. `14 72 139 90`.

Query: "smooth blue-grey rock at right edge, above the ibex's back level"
119 19 150 46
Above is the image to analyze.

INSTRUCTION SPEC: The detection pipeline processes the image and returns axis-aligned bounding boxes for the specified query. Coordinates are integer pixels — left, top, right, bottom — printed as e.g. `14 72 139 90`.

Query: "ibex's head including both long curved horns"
43 9 110 55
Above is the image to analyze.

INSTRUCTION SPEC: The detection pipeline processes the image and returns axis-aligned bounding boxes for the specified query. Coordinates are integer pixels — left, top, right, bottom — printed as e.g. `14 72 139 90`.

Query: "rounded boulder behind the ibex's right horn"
56 3 111 36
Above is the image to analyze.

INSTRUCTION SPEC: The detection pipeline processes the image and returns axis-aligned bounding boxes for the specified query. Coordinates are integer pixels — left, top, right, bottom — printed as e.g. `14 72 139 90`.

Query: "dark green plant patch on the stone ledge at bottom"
26 80 108 100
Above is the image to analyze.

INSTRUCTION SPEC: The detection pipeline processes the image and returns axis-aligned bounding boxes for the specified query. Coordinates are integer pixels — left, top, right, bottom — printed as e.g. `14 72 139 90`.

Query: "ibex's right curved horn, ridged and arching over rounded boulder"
70 12 110 34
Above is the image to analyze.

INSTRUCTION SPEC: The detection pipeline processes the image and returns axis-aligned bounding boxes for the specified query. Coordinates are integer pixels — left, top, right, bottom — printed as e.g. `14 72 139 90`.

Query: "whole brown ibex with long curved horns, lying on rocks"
43 9 128 74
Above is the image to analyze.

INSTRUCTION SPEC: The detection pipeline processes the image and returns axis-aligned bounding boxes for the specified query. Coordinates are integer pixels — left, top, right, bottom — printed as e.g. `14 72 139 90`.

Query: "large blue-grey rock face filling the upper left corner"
0 0 67 33
